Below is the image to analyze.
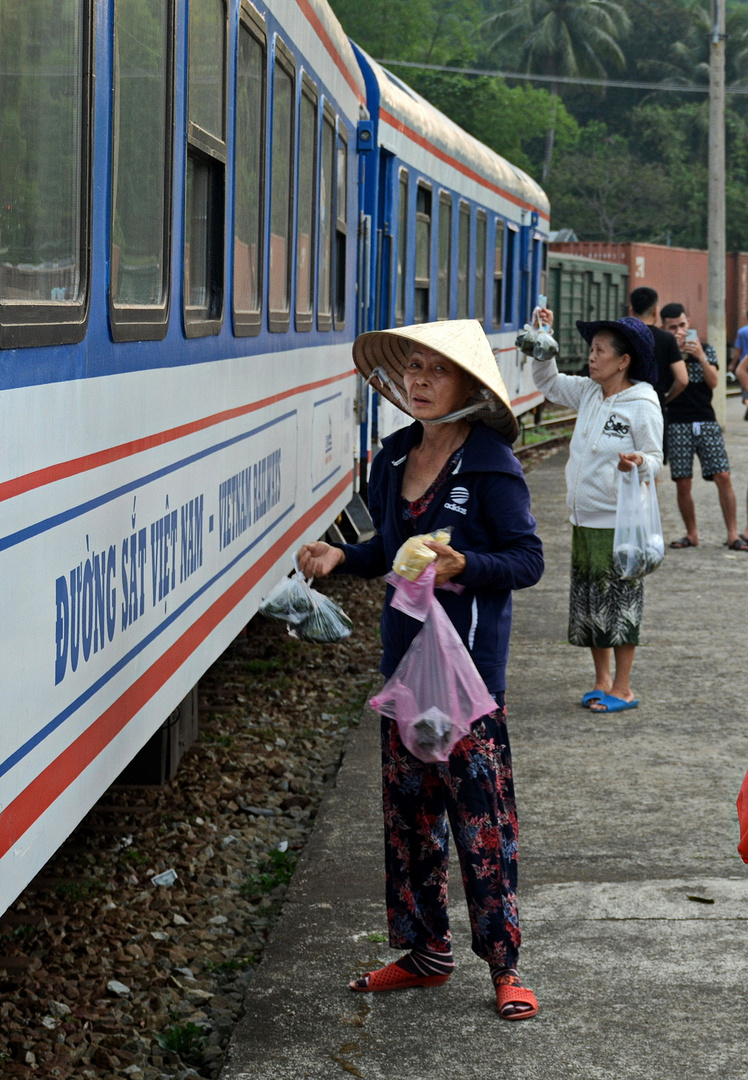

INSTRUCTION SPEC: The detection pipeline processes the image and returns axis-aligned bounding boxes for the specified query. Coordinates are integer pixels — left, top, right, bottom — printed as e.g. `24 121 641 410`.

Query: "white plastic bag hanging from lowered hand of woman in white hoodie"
613 465 665 581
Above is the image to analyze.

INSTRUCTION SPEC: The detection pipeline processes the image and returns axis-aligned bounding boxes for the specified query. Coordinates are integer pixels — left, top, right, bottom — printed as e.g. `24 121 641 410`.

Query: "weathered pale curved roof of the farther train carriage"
349 46 550 221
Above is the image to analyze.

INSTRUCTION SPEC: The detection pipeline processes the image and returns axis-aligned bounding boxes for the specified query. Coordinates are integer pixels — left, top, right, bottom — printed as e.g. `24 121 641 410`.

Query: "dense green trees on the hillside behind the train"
331 0 748 249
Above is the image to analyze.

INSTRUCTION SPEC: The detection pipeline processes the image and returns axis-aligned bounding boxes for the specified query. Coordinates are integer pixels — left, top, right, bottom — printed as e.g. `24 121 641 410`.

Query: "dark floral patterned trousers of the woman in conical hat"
382 696 521 968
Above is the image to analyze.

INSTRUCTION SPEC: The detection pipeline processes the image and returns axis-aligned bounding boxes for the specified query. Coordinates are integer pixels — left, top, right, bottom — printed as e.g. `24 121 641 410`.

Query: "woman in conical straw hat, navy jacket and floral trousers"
299 320 543 1020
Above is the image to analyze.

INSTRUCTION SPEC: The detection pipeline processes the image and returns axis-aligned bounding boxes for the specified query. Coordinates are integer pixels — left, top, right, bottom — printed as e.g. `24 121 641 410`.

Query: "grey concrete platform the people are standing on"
221 399 748 1080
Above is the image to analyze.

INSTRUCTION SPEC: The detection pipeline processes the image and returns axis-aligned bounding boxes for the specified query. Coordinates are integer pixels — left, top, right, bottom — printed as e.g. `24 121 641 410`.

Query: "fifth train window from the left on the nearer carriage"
268 41 295 332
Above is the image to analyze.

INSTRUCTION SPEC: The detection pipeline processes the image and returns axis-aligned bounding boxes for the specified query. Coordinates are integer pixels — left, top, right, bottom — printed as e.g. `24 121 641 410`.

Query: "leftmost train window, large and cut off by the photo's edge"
0 0 93 349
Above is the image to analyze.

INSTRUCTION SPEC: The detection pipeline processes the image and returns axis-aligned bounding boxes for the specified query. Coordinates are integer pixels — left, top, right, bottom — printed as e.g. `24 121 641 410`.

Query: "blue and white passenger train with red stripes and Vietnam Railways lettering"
0 0 549 913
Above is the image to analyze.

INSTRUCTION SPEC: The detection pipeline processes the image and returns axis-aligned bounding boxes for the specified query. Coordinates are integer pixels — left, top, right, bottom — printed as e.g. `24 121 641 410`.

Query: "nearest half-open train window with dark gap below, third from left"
183 0 227 337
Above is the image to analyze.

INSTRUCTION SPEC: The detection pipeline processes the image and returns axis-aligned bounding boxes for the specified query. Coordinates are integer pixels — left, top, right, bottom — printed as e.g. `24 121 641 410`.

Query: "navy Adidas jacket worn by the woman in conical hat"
336 421 543 693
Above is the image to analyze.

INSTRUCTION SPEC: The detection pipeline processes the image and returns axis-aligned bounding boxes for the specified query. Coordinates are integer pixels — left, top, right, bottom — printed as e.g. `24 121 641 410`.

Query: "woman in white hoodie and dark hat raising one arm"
532 309 663 713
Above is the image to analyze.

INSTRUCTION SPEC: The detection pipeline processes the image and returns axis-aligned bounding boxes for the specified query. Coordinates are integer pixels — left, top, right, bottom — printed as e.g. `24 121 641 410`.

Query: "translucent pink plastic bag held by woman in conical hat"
369 566 497 761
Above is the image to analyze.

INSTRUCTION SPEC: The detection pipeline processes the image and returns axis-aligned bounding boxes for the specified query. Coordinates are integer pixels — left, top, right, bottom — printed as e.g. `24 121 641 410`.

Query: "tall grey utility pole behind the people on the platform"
707 0 726 428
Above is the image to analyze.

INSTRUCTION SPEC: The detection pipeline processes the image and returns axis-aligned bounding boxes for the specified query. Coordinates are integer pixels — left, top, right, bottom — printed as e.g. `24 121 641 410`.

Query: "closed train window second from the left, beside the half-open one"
109 0 174 341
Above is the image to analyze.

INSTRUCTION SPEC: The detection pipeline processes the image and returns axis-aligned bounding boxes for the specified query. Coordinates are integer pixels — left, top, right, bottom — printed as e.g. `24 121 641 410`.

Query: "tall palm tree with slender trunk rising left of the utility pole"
486 0 630 181
